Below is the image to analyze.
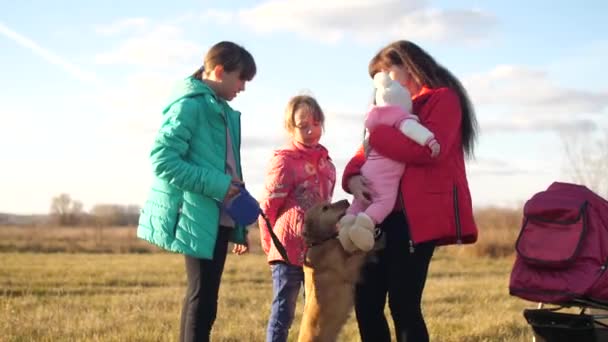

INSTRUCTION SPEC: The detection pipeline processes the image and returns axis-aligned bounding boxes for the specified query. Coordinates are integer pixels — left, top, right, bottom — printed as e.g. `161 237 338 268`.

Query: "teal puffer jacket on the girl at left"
137 77 247 259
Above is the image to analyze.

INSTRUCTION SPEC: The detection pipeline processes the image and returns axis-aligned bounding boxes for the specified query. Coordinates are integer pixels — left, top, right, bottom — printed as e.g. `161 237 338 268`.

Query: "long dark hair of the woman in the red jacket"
369 40 479 157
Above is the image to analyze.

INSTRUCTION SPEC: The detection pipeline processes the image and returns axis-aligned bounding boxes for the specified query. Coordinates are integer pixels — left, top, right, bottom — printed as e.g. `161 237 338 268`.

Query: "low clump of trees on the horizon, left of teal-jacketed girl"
50 193 140 227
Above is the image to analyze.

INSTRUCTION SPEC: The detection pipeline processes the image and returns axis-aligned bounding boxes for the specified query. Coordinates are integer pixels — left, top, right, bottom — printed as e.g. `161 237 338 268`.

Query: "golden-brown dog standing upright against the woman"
298 200 365 342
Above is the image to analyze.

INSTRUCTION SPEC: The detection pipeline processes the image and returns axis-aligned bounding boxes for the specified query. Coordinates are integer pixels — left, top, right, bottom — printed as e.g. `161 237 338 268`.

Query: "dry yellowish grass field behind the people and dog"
0 250 533 341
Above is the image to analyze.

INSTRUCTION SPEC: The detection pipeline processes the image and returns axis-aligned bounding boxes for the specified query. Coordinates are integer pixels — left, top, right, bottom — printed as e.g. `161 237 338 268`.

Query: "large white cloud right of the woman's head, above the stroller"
463 65 608 133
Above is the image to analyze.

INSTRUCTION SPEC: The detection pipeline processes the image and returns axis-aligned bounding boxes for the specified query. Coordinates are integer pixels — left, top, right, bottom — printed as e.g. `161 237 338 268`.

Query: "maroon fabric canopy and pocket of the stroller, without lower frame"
509 182 608 304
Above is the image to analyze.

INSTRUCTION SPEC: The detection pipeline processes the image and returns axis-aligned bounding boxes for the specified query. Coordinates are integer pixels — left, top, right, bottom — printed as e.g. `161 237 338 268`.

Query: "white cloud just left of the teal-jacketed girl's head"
95 22 203 67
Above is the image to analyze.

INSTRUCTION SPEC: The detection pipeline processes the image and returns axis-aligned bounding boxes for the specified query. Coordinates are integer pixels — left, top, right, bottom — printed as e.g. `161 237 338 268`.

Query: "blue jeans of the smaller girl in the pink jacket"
266 262 304 342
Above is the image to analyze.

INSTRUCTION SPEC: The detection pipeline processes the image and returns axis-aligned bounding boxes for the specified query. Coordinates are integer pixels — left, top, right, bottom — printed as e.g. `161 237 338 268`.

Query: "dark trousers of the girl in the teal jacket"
180 226 232 342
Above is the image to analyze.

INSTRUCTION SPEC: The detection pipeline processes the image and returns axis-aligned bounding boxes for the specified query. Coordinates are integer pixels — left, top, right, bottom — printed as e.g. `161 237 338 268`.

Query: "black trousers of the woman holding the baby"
355 213 435 342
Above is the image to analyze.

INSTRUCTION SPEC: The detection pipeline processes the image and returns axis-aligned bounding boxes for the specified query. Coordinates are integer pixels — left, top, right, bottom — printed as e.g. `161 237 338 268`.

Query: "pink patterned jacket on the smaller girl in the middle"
259 142 336 266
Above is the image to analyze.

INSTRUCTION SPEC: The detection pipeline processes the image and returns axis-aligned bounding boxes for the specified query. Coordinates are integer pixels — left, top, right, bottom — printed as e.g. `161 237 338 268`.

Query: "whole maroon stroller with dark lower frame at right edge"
509 183 608 342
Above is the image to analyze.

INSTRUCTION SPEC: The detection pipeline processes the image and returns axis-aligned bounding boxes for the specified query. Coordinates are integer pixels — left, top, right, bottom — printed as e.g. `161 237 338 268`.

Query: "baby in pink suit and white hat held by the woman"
338 72 439 253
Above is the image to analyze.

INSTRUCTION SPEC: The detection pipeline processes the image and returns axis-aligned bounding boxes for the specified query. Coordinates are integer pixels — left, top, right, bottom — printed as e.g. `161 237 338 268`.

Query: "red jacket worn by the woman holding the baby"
342 87 477 245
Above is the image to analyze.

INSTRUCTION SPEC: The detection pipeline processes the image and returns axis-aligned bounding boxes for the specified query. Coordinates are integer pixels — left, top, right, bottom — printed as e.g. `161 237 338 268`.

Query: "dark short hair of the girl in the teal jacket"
192 41 256 81
